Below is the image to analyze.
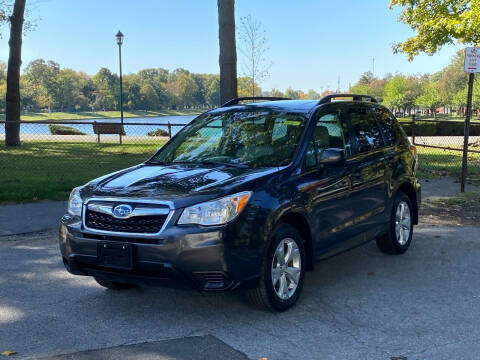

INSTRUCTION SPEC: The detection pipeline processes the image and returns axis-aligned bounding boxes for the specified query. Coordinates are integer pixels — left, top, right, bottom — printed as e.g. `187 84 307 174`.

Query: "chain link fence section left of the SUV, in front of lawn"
0 119 186 203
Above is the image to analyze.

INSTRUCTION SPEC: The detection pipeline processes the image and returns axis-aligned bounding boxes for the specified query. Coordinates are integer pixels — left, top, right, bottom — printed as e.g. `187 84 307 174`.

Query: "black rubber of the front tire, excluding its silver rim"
246 224 307 311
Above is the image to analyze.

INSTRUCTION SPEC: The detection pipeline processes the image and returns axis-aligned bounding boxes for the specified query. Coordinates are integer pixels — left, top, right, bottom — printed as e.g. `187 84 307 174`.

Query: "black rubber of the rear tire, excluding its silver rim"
377 192 413 255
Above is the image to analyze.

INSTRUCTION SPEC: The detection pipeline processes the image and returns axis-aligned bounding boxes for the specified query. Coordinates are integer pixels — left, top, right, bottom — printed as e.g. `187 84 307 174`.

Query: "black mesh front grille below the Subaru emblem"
85 208 167 234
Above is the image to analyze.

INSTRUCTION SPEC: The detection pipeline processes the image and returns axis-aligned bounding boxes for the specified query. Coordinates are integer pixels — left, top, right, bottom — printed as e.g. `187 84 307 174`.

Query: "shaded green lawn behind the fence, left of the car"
0 140 164 203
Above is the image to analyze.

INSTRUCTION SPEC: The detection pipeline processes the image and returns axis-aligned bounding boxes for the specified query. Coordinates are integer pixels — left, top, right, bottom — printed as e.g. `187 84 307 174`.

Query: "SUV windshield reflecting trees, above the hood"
149 111 306 167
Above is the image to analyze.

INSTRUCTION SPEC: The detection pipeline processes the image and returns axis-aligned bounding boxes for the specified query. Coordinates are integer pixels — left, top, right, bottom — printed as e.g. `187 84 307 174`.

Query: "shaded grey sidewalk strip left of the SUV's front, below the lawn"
0 201 67 236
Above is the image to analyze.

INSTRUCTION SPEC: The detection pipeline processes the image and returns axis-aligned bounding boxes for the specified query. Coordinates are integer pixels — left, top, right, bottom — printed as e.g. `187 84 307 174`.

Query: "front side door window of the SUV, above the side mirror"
305 112 349 167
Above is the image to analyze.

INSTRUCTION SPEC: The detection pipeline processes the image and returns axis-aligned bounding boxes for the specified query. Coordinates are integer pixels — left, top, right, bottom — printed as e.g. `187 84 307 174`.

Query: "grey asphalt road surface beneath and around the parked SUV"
0 226 480 360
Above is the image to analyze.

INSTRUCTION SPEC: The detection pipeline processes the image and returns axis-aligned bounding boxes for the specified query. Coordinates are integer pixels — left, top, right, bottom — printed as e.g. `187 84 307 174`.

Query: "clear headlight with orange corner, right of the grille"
178 191 252 225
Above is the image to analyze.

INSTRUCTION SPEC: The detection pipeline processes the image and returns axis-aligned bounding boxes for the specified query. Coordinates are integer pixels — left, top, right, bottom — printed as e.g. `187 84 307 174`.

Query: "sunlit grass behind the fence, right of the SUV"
417 146 480 179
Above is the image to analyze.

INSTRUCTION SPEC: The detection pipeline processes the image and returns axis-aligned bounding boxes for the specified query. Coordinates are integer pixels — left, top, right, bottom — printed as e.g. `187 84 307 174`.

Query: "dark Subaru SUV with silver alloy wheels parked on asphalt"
60 94 420 311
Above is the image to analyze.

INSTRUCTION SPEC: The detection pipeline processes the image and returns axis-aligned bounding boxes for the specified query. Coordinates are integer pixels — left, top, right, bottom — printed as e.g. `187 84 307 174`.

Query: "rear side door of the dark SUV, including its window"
346 104 387 240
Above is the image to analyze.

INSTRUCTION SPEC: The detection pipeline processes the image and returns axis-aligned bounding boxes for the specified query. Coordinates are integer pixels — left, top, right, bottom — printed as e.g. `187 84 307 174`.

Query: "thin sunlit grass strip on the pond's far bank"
0 109 203 121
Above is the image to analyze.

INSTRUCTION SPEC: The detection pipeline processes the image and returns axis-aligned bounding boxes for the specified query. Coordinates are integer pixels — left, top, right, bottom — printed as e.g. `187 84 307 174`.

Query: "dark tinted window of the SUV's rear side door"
348 107 383 153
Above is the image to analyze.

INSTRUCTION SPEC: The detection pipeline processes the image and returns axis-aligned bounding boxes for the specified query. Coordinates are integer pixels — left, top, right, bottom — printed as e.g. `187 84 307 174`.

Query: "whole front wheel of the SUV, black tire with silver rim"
246 224 306 311
